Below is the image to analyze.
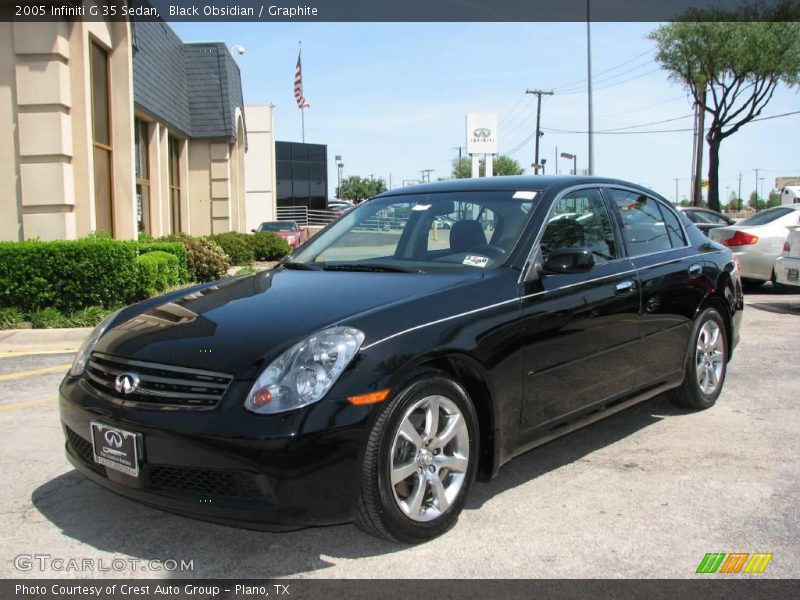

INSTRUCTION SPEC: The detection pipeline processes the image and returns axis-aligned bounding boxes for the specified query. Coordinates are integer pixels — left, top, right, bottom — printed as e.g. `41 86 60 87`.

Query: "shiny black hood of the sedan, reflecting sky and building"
95 269 482 378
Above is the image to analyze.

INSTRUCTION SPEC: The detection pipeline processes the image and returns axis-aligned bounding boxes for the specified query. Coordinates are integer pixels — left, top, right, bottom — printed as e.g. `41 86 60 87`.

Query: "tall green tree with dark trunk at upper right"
649 0 800 210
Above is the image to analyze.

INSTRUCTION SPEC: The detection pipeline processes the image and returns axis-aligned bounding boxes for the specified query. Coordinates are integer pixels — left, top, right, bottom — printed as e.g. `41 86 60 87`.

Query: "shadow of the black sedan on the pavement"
31 397 688 578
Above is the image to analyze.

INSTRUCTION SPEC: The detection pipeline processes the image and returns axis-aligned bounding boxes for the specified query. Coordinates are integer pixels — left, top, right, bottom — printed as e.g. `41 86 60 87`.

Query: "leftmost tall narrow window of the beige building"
89 42 114 234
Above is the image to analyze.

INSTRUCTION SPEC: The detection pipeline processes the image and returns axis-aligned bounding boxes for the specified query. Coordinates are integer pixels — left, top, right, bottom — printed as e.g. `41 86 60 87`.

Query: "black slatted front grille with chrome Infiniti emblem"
84 352 233 408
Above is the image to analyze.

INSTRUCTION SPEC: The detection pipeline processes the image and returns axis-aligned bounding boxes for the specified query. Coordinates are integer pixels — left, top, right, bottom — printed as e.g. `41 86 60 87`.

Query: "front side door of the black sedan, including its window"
522 188 640 435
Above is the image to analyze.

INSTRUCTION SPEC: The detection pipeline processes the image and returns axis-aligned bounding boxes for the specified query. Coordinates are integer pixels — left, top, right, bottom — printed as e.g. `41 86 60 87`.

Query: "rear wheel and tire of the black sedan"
668 308 728 410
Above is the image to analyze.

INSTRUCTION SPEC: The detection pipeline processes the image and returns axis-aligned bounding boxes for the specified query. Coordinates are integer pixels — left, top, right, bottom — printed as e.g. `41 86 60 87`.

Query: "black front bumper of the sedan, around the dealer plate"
59 378 366 530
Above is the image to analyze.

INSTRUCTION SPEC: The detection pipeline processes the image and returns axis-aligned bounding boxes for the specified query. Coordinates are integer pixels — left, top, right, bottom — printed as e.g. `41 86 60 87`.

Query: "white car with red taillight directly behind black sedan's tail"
709 204 800 286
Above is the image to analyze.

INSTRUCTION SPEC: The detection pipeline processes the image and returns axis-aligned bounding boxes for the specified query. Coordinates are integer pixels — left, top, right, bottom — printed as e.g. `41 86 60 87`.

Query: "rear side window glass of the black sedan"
611 190 685 256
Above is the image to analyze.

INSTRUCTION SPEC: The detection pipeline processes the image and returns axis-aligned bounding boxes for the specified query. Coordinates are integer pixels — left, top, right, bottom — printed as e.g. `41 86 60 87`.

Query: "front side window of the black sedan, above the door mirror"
541 189 619 263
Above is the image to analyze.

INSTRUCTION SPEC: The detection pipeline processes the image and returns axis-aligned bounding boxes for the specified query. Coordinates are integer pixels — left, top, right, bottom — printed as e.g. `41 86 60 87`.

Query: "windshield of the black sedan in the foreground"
284 190 537 272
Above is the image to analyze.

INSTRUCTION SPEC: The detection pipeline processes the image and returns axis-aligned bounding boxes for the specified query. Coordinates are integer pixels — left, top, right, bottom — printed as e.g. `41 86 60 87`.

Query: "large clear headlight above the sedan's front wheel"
244 327 364 414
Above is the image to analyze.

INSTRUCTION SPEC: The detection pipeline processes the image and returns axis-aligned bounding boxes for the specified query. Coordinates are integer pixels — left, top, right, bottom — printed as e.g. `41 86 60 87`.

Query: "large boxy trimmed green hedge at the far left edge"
0 239 138 312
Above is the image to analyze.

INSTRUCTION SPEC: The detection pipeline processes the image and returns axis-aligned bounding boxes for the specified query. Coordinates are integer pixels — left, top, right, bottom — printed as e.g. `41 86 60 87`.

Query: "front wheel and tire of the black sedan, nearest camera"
354 371 479 544
